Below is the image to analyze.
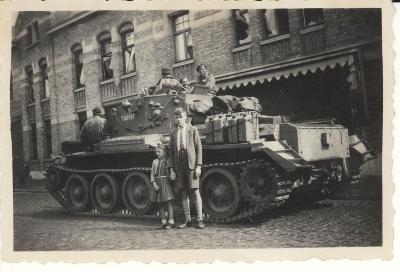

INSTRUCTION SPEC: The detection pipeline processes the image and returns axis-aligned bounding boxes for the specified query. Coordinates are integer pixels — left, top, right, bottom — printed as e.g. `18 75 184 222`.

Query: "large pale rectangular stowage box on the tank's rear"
279 123 349 161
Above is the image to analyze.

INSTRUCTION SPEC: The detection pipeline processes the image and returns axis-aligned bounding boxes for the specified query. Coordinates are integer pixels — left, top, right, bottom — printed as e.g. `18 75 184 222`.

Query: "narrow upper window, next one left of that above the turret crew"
120 24 136 74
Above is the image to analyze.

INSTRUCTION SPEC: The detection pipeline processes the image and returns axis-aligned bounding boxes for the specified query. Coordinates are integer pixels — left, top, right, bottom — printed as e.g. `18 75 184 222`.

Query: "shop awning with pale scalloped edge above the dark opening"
216 54 358 90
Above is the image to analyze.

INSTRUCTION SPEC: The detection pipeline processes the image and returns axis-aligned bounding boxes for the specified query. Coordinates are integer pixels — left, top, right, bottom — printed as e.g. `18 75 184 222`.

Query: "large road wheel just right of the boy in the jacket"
201 168 240 219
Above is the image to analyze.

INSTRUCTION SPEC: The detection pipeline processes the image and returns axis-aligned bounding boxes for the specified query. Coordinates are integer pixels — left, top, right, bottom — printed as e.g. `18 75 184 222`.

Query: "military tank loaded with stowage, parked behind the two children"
47 93 369 223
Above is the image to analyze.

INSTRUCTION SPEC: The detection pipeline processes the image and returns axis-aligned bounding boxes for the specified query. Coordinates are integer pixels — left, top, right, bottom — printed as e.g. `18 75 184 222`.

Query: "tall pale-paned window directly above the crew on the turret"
173 12 193 62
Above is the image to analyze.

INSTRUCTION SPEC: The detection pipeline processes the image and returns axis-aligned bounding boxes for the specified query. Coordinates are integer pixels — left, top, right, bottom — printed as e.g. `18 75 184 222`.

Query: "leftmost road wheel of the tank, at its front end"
66 174 89 212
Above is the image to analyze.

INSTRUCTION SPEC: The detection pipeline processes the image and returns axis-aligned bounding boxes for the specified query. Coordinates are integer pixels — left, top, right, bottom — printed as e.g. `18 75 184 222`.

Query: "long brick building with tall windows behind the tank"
10 9 383 171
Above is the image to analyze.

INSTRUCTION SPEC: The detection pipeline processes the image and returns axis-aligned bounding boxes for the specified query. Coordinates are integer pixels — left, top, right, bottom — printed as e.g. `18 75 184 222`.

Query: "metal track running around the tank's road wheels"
46 159 292 223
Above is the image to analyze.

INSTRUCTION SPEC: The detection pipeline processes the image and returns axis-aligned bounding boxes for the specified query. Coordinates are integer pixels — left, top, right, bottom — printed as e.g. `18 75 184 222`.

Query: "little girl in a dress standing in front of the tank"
150 143 174 230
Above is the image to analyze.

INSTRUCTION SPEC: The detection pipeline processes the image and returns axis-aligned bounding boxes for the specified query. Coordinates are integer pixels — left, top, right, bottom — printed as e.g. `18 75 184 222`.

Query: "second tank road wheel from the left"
90 173 120 213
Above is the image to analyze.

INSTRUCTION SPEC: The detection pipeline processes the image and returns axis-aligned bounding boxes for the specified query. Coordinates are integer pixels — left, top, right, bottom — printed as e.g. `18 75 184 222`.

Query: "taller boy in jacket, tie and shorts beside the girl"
169 108 205 229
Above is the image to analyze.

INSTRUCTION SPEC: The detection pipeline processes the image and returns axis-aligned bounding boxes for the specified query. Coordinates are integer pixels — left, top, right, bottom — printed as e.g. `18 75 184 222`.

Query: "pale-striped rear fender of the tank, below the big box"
251 141 312 172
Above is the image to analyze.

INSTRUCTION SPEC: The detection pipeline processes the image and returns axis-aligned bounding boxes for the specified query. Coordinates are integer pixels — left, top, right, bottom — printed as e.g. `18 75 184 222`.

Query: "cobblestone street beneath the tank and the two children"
14 192 382 251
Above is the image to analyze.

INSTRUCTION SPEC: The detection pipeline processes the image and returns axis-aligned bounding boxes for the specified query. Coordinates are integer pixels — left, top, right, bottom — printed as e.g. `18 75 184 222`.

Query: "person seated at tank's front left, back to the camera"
81 106 107 150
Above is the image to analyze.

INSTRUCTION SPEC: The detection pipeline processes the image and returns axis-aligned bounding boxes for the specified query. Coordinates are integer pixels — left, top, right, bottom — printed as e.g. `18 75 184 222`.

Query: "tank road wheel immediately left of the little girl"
122 172 151 215
